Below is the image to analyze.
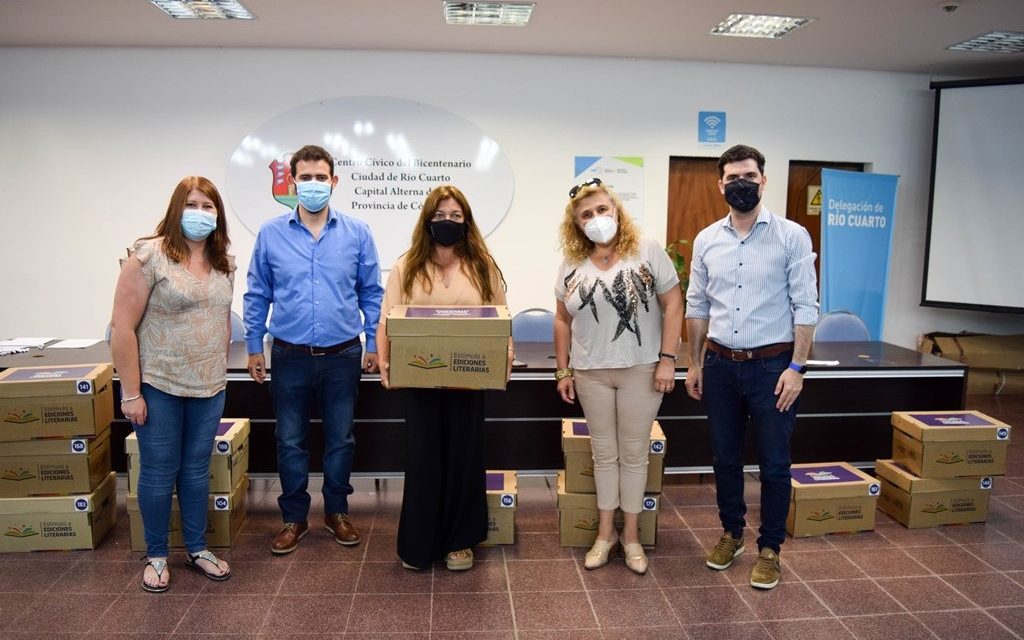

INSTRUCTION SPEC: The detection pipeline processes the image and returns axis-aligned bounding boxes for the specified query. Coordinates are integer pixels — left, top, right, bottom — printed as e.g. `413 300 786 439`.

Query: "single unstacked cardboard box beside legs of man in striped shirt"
785 462 882 538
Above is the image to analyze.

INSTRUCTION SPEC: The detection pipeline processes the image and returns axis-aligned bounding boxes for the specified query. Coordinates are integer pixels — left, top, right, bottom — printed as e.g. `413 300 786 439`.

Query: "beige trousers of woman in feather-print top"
573 362 663 513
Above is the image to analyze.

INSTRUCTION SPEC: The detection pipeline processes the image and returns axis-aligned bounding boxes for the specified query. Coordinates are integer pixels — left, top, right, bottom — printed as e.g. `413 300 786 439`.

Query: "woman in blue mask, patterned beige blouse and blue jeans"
111 176 234 593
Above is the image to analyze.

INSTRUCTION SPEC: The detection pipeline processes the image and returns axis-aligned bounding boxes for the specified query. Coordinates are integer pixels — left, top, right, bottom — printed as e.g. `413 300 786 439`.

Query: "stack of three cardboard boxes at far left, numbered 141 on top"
0 364 117 552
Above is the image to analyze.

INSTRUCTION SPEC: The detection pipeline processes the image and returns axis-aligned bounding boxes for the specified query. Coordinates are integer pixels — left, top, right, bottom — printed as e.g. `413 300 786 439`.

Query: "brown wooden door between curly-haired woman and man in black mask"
665 157 729 341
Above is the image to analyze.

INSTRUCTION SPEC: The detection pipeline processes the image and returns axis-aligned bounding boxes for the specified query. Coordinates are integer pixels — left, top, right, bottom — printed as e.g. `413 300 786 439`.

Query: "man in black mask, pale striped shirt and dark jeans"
686 144 818 589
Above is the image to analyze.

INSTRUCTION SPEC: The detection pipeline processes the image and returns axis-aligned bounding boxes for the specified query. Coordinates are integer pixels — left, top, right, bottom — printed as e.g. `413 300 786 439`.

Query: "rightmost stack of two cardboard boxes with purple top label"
874 411 1011 528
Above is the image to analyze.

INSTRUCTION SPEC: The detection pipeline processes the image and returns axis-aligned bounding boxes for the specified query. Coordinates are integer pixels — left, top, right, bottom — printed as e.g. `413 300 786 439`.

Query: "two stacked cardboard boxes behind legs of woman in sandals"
125 418 249 551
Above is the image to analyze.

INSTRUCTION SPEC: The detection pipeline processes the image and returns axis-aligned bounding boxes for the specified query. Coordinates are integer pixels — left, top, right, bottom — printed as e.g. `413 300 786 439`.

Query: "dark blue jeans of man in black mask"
703 350 797 553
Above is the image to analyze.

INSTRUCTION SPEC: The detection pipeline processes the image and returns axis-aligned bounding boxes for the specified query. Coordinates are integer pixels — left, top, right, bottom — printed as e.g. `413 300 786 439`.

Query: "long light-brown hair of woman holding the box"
401 184 505 304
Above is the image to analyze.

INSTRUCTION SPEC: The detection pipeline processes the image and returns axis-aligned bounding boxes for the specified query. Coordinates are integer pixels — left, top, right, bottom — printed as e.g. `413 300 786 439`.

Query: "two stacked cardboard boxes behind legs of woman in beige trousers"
557 419 666 547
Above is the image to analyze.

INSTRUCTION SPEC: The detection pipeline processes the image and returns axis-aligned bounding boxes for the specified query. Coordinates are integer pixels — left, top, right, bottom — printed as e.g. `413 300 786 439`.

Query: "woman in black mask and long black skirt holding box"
377 184 513 570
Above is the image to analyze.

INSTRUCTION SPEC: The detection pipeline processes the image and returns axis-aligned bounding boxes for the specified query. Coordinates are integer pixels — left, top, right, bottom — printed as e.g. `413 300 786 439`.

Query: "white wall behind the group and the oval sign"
0 48 1024 347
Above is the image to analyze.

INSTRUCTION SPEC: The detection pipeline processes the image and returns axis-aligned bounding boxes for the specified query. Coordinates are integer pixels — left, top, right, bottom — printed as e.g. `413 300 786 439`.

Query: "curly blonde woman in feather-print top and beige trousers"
555 178 683 573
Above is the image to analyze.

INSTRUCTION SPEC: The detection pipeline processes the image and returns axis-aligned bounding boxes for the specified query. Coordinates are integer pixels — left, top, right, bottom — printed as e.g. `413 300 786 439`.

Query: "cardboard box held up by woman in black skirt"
387 305 512 389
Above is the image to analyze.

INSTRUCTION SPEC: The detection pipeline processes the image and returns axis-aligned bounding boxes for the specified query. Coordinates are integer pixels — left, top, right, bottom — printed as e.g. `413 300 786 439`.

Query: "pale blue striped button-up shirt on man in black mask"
686 207 818 349
